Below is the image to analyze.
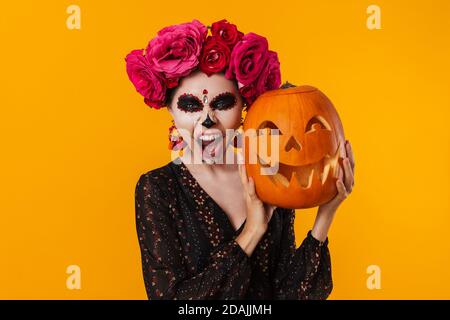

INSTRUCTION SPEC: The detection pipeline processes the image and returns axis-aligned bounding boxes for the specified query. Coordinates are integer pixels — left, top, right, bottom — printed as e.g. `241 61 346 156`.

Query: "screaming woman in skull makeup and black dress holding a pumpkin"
127 20 354 299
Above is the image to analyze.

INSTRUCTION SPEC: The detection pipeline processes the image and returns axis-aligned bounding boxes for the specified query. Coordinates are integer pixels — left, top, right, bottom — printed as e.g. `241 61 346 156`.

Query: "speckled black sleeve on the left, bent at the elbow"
135 174 251 299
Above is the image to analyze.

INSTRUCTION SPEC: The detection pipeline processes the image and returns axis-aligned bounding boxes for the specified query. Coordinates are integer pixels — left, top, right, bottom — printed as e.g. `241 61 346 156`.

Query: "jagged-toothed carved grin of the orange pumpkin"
257 146 339 189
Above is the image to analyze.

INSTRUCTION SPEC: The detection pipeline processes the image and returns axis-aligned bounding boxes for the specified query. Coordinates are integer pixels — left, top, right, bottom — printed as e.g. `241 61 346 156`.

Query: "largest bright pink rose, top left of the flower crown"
146 19 208 80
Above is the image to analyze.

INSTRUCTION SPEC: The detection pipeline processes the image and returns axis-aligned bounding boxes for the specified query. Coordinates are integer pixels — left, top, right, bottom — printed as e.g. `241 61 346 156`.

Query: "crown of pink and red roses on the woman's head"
125 19 281 109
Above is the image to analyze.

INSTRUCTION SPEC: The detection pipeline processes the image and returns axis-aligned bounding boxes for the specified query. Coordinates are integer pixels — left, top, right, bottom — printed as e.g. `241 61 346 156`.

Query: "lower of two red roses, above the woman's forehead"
199 36 231 76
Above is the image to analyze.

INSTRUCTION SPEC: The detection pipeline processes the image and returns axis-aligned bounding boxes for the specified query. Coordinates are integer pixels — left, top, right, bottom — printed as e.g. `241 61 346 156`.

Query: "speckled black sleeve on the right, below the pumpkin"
274 209 333 300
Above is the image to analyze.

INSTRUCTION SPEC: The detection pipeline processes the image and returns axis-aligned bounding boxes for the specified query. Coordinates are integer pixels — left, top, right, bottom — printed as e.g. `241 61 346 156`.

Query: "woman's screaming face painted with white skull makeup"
169 71 243 163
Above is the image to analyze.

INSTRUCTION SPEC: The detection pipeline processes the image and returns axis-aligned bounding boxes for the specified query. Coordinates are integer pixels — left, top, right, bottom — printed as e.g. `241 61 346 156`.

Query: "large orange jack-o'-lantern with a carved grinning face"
244 83 346 209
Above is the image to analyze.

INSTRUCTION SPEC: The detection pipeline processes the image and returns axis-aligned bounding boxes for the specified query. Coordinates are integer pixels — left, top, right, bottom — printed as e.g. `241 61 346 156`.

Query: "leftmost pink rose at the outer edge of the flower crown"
125 50 166 109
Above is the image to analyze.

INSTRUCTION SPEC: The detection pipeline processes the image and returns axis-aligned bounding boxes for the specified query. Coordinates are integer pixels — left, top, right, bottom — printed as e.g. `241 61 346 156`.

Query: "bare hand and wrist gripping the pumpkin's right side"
311 140 355 241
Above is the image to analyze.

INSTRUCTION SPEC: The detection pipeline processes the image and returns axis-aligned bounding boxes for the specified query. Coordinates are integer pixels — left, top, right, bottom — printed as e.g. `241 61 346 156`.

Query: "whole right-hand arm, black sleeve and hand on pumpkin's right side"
274 140 355 299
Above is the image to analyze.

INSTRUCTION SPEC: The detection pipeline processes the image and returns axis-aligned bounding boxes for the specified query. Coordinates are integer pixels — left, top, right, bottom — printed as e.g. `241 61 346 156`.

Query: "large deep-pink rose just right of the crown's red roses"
225 32 269 85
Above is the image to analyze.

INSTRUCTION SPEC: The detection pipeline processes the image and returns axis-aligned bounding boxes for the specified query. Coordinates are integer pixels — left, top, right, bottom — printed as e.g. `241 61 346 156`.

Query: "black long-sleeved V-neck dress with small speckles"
135 161 333 300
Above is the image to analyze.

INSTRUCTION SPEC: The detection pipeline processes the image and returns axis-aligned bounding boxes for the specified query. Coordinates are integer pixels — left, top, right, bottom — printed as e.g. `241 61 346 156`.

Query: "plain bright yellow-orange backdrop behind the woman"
0 0 450 299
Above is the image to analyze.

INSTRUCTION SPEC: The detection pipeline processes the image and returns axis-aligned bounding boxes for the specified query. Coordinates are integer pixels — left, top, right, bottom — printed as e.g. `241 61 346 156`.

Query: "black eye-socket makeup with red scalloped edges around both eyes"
177 89 237 112
